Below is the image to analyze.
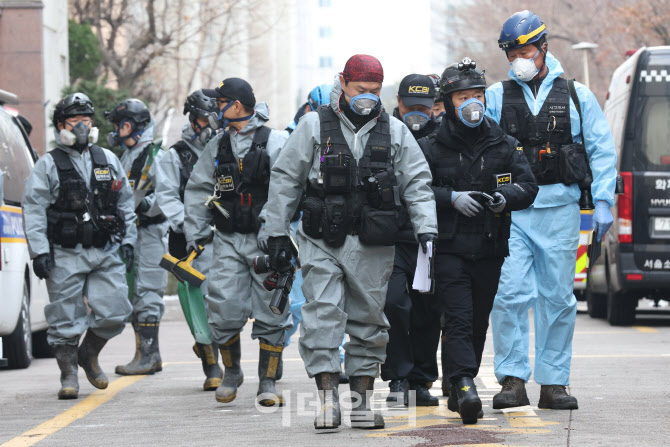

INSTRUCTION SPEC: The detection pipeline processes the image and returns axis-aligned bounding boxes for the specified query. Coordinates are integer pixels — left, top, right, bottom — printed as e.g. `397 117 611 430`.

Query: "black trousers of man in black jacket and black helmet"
435 253 504 383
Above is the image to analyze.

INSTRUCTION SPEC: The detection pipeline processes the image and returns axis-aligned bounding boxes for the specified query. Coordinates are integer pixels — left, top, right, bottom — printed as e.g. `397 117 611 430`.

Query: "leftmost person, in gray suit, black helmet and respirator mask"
23 93 137 399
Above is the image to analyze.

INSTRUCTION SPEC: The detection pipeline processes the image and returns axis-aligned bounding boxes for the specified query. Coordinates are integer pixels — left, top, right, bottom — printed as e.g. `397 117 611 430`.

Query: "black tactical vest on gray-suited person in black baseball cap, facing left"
214 126 272 234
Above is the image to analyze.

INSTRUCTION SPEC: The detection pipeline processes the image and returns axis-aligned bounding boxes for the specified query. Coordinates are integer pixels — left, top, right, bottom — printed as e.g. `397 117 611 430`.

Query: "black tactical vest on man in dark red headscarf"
302 105 400 247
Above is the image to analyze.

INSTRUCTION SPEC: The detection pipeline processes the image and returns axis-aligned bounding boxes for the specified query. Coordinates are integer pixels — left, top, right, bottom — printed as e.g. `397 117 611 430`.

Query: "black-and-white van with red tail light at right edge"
585 46 670 325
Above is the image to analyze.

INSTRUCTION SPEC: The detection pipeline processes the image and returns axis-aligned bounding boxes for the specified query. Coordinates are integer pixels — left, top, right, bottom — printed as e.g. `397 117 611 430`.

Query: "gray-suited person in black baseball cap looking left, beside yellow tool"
184 78 292 406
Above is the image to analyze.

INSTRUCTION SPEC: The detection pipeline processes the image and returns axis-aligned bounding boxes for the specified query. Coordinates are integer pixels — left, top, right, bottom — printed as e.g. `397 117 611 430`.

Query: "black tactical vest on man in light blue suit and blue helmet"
500 78 573 185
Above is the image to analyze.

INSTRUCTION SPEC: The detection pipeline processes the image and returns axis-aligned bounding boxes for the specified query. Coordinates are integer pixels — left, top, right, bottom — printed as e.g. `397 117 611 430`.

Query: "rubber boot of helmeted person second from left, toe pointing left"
115 321 163 376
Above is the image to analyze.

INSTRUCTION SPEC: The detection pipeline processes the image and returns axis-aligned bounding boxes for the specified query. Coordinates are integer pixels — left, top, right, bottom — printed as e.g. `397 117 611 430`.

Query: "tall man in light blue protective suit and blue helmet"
486 11 617 409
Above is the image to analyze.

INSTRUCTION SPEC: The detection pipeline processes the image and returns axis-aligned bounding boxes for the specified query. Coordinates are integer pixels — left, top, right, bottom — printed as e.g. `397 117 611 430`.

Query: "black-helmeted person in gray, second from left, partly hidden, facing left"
105 99 168 375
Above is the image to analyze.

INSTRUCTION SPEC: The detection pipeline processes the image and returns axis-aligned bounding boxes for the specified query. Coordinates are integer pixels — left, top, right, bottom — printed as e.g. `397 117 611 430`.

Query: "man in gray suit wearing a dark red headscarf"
267 55 444 429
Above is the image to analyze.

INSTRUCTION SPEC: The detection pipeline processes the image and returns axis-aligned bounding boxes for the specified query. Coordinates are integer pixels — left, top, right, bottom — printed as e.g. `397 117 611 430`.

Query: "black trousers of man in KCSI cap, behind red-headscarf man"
381 243 440 384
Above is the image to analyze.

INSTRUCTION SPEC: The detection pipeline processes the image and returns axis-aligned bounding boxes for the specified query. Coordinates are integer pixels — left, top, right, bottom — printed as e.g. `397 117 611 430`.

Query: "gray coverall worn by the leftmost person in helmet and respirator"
23 139 137 346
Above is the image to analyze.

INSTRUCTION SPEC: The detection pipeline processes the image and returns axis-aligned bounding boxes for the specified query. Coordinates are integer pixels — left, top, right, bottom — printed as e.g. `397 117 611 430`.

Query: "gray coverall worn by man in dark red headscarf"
266 82 437 377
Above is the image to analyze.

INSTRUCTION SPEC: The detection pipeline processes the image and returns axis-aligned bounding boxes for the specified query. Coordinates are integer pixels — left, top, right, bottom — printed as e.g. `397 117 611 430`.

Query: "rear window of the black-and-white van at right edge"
635 96 670 171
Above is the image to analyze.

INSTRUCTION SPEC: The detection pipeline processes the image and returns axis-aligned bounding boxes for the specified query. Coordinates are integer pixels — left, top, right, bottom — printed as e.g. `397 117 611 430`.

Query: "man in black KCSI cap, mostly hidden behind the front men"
381 74 440 406
